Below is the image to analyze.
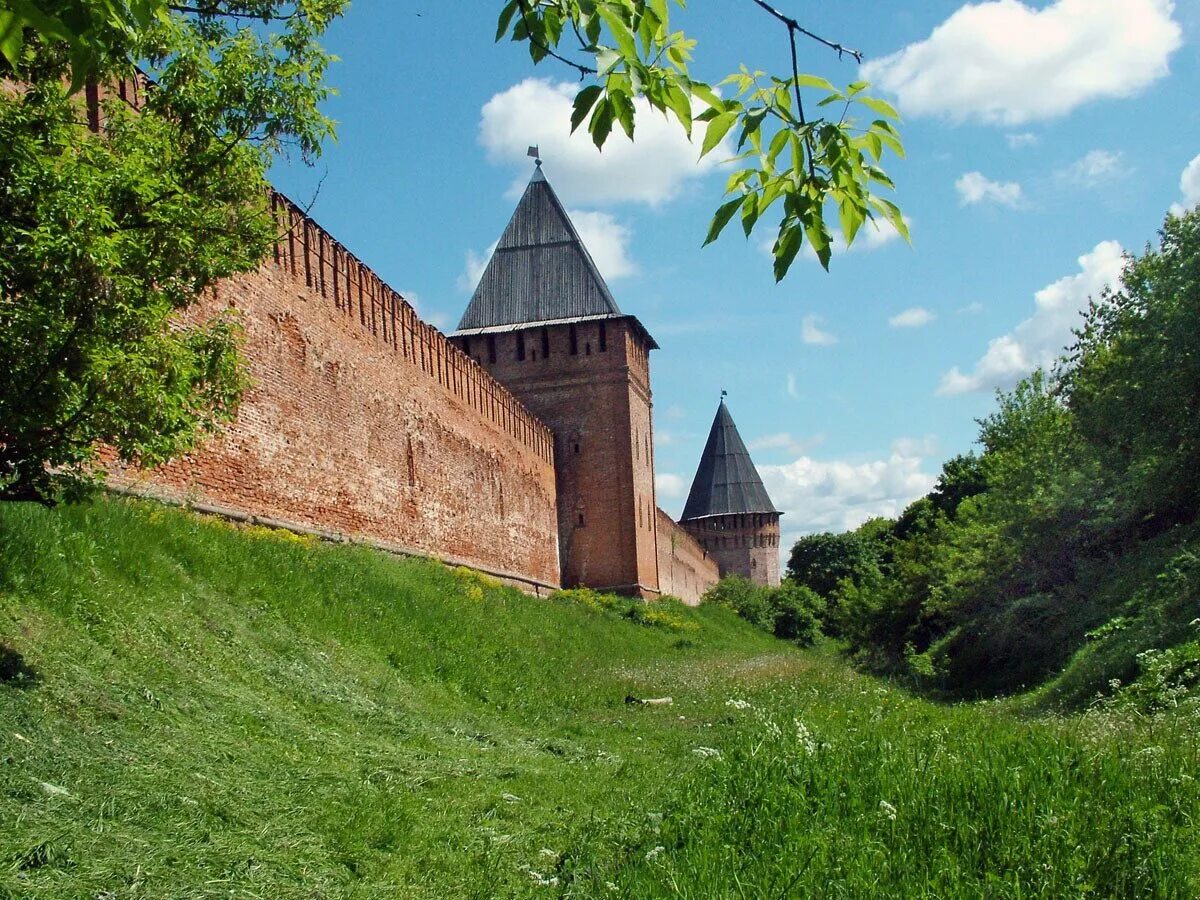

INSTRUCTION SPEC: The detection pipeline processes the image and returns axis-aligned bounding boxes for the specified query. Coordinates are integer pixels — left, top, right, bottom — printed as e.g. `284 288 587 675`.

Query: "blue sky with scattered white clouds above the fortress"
272 0 1200 541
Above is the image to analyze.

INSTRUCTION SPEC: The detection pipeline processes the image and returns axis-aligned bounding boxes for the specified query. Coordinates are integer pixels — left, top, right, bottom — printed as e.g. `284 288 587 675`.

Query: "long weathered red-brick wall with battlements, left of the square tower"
113 198 559 586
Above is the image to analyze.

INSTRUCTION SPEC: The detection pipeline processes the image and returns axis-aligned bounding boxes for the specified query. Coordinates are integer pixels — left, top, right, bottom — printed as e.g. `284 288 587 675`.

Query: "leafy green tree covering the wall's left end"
0 0 344 503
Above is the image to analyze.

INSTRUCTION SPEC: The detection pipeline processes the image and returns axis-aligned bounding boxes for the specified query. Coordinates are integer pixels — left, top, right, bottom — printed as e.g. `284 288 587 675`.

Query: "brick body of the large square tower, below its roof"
454 319 659 596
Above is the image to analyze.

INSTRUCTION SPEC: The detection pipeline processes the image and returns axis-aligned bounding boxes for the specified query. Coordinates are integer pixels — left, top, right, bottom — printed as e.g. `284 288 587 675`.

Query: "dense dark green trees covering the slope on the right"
788 211 1200 706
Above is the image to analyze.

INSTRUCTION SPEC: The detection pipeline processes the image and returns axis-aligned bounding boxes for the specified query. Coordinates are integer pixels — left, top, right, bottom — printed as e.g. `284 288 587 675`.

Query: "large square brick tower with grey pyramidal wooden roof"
450 167 662 598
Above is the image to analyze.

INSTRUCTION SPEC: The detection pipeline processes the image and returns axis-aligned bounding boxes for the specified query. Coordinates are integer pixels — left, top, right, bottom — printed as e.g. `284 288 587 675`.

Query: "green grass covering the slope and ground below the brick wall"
0 500 1200 899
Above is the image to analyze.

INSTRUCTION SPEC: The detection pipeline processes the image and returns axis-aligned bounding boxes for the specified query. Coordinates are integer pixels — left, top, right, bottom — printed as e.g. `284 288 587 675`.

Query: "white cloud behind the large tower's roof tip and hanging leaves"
479 78 728 205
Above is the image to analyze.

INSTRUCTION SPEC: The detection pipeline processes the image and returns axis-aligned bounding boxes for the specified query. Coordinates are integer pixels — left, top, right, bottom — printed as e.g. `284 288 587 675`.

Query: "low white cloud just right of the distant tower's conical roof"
758 439 937 540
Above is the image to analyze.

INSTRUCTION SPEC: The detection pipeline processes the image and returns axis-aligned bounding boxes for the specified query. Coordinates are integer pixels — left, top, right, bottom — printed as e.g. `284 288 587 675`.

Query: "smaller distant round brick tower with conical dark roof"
679 400 782 587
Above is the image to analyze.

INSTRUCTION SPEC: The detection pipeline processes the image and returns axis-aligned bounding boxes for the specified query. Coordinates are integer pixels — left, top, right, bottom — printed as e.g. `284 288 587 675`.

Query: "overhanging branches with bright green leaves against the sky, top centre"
497 0 908 281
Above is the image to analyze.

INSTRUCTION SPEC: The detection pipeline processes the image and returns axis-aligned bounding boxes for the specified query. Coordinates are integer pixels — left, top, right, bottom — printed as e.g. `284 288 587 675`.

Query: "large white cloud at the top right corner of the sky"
863 0 1182 126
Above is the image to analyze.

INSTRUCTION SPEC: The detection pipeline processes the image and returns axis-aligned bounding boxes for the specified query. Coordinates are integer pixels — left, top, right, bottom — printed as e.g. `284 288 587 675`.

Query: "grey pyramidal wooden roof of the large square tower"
458 168 622 334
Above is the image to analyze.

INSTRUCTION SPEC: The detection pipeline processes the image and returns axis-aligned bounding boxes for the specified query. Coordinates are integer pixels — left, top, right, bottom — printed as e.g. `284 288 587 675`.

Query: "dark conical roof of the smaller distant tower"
679 400 779 522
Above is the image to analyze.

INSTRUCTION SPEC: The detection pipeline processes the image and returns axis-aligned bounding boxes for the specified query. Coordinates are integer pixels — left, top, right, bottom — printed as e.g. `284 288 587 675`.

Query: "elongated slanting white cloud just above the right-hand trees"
937 241 1124 395
